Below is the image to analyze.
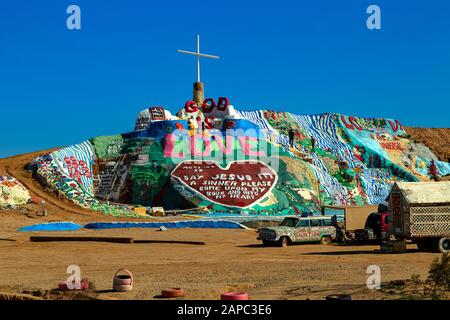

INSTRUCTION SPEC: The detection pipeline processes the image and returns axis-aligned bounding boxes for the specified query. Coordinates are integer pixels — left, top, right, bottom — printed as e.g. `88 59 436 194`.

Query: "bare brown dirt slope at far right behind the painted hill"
405 127 450 162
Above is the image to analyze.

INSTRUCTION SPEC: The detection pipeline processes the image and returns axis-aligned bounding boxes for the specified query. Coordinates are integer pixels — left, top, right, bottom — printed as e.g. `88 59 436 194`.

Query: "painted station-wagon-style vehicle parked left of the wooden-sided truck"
257 217 336 247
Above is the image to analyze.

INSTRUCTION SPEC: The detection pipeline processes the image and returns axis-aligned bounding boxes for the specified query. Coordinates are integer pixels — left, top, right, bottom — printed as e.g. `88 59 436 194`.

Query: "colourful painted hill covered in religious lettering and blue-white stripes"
25 102 450 216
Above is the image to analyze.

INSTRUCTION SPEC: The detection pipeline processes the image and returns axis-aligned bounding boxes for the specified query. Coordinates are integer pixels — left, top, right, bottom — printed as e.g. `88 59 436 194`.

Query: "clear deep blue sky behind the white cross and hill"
0 0 450 157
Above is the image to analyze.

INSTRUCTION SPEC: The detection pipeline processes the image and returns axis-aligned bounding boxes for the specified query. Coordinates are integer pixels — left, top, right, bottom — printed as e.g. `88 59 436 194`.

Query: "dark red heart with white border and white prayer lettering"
172 161 278 208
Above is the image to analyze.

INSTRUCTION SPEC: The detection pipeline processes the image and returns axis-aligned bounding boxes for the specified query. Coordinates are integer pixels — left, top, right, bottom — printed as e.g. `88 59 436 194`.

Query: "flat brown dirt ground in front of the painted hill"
0 152 446 300
